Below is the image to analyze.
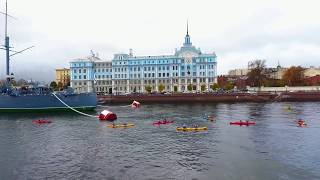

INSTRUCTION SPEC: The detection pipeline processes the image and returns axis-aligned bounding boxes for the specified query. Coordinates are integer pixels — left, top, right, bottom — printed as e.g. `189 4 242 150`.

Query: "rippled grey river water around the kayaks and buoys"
0 103 320 180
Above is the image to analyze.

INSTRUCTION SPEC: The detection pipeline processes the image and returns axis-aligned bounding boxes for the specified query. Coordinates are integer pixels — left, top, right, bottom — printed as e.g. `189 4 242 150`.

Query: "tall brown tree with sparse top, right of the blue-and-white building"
247 59 266 87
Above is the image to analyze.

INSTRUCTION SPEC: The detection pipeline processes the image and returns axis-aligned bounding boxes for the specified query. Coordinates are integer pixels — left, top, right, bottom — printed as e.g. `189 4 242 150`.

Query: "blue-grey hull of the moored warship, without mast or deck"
0 93 97 112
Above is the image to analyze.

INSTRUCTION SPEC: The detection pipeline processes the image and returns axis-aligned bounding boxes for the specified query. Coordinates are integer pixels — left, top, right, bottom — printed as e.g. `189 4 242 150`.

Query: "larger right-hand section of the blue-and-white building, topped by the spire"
112 30 217 93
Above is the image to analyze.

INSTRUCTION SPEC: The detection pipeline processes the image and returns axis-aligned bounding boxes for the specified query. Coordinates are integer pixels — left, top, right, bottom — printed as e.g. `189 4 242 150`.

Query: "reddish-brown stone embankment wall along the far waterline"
98 92 320 104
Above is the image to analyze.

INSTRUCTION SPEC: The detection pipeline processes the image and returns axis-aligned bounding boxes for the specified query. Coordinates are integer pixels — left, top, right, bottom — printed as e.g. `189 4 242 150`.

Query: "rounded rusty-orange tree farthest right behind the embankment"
282 66 304 86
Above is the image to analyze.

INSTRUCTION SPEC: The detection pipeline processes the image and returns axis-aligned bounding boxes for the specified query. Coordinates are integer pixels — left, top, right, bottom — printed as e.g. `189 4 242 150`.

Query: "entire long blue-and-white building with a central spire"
70 28 217 93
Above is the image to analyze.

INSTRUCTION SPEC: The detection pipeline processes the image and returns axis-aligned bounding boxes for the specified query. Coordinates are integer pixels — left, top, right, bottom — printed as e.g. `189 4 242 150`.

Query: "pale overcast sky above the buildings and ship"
0 0 320 81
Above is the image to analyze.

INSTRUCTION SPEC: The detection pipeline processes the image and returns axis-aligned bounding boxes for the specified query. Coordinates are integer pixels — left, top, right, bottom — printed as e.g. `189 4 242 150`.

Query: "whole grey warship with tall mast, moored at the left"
0 1 97 112
